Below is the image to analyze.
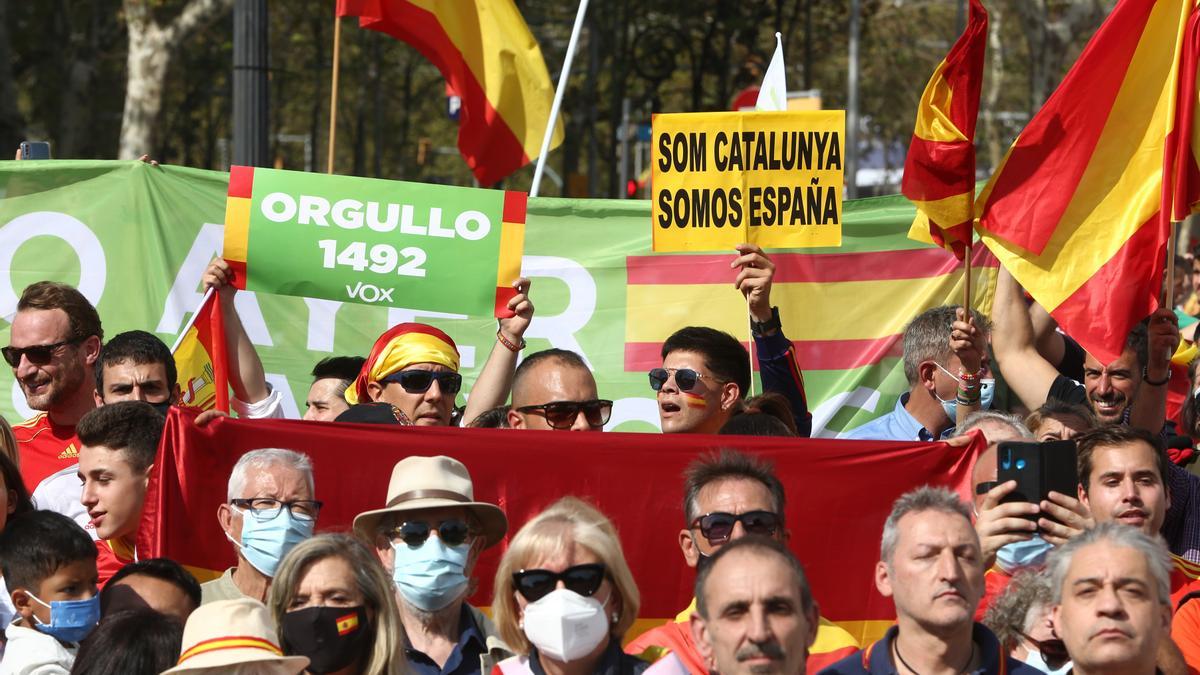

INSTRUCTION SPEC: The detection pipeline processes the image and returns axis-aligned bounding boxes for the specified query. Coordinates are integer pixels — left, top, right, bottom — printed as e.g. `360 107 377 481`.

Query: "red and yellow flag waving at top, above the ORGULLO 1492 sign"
337 0 563 186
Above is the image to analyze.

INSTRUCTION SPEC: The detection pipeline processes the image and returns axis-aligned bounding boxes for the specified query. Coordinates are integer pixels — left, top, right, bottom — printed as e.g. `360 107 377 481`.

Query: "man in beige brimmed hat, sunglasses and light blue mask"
354 456 511 675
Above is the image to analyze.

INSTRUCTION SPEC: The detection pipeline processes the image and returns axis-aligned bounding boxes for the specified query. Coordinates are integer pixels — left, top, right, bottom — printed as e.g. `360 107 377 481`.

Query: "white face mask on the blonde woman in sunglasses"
523 589 608 662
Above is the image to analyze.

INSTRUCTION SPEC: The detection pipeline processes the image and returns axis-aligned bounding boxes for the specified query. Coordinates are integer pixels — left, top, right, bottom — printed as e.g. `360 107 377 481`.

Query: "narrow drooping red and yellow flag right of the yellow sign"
900 0 988 261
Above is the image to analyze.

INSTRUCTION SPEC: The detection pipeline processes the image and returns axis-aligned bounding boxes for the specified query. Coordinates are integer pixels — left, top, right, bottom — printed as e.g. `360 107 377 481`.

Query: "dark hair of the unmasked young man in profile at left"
76 401 166 473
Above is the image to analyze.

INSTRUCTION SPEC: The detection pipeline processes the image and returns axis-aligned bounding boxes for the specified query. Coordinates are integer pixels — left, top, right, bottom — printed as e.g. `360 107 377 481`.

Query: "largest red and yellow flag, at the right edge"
977 0 1195 363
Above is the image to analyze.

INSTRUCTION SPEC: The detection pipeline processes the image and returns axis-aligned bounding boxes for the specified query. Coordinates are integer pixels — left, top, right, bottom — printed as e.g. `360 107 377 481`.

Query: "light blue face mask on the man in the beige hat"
391 534 470 611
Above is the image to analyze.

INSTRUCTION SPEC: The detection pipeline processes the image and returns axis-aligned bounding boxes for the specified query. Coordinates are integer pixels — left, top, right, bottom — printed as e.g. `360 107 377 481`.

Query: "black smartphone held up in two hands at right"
996 440 1079 521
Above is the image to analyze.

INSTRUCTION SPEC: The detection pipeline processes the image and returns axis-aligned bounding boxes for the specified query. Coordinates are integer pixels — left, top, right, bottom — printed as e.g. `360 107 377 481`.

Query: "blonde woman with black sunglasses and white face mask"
492 497 649 675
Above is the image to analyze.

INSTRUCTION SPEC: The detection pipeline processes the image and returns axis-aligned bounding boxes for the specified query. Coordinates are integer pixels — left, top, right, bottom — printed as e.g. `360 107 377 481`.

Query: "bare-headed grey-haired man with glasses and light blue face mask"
200 448 323 604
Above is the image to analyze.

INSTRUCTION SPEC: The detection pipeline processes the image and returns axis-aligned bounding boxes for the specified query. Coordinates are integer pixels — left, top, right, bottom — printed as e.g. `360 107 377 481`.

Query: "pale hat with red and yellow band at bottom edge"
163 598 308 675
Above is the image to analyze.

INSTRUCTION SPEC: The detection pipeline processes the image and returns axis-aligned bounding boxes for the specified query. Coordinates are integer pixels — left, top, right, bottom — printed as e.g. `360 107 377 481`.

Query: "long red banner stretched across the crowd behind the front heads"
138 408 983 641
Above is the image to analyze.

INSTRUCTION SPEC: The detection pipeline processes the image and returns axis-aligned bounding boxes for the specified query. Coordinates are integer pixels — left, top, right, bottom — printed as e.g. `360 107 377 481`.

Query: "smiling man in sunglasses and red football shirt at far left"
0 281 104 492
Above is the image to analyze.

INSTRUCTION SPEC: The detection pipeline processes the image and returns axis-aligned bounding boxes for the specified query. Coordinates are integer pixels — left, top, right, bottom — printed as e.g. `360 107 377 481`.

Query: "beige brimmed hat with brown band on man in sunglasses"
354 455 509 546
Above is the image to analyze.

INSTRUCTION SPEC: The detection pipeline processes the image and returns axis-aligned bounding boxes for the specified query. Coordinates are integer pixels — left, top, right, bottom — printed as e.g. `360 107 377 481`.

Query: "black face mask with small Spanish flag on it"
280 605 372 674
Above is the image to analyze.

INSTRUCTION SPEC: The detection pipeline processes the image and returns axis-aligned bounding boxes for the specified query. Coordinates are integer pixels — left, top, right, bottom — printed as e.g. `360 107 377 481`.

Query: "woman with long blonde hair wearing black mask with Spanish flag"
269 534 406 675
